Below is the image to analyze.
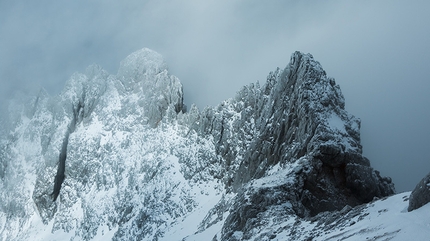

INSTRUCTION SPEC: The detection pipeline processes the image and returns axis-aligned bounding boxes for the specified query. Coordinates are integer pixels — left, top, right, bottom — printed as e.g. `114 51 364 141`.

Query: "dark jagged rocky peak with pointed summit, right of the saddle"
192 52 394 240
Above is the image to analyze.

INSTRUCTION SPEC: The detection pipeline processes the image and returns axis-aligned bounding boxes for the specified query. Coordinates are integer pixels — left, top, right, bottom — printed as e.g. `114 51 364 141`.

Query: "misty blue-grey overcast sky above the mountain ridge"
0 0 430 191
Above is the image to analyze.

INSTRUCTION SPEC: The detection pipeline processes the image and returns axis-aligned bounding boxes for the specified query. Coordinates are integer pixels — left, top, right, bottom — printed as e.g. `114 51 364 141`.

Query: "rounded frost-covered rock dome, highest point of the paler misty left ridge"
116 48 184 127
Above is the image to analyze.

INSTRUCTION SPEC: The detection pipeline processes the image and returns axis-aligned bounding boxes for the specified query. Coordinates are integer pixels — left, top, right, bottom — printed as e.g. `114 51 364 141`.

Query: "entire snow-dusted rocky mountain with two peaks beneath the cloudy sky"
0 49 430 240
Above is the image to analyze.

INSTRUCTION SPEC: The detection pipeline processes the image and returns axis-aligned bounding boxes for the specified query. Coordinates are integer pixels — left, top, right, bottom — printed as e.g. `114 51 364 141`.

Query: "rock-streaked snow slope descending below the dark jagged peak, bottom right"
188 192 430 241
